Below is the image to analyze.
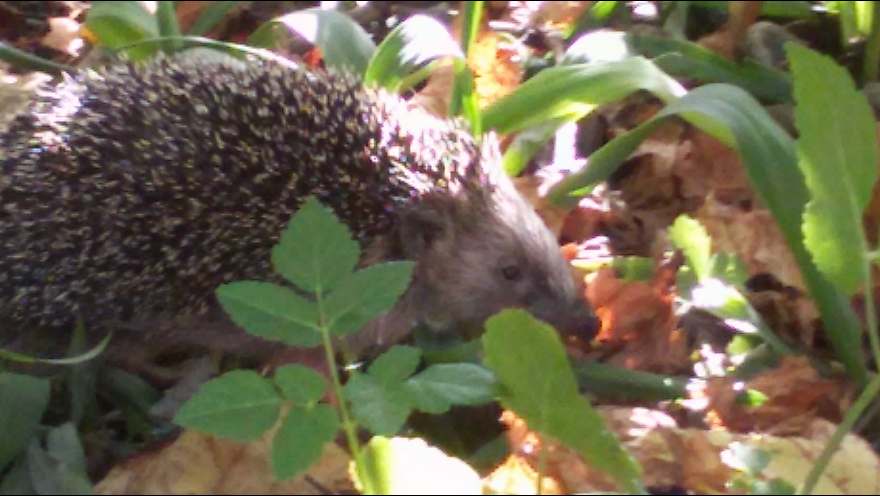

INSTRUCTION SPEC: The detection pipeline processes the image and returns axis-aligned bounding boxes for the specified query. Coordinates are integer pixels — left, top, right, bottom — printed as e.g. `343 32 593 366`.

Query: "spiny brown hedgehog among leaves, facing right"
0 57 596 354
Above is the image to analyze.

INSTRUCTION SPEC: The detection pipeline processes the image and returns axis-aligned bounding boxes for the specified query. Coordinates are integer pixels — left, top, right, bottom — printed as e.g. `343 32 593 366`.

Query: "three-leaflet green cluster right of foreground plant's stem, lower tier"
345 346 495 435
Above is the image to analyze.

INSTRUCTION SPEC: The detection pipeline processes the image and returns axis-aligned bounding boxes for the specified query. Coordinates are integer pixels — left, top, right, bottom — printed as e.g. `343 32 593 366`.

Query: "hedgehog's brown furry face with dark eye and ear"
402 175 597 338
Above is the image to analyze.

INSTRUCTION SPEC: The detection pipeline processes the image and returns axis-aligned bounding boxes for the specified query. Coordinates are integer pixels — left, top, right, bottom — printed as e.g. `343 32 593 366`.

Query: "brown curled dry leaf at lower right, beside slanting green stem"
699 357 853 436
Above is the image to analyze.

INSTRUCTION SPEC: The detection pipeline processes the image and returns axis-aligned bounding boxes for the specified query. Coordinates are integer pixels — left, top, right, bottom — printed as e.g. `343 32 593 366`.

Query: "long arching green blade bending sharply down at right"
547 84 867 384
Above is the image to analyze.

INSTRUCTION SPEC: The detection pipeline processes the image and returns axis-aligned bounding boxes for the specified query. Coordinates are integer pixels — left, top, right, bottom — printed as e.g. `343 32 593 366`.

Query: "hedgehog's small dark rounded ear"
399 198 455 260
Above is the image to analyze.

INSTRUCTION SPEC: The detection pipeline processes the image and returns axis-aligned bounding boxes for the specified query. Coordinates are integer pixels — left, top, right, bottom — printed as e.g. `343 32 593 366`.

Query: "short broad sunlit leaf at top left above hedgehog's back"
85 1 159 60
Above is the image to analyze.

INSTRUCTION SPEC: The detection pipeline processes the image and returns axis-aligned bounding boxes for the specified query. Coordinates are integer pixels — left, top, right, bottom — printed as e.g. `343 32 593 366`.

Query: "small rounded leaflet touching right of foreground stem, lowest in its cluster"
344 373 412 435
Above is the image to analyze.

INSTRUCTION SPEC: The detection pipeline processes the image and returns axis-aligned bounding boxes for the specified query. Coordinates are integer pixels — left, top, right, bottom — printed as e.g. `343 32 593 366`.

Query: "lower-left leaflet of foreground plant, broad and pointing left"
174 370 281 442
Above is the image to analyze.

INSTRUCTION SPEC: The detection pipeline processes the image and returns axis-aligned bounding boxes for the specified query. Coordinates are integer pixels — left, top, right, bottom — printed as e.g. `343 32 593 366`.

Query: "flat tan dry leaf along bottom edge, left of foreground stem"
95 430 354 494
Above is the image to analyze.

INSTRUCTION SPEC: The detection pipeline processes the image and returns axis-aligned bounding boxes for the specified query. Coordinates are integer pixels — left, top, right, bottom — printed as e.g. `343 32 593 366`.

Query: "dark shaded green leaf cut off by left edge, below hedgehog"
0 372 49 471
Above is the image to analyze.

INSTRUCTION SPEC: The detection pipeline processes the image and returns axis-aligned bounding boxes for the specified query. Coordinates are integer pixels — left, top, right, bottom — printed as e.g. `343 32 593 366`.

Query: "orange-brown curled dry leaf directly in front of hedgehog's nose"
587 268 689 373
